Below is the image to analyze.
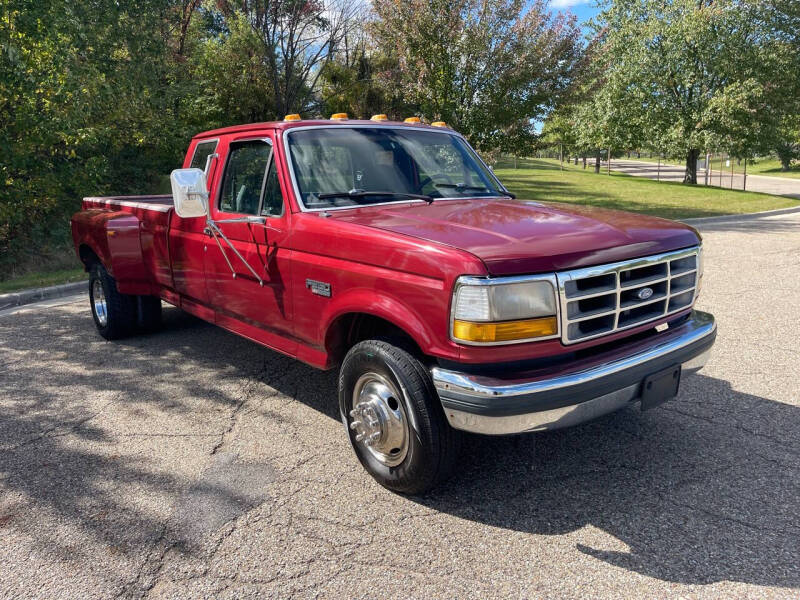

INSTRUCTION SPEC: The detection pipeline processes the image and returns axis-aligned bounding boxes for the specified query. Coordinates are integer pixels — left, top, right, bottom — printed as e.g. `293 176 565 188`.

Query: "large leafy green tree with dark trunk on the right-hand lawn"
595 0 797 183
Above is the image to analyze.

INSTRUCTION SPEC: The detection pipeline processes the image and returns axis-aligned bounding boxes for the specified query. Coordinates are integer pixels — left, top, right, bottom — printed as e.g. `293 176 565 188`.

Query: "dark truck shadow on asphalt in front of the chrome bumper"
419 375 800 587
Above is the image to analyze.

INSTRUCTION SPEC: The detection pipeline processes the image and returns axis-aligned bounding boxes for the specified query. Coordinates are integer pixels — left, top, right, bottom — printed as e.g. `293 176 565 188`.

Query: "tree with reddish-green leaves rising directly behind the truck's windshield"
372 0 581 150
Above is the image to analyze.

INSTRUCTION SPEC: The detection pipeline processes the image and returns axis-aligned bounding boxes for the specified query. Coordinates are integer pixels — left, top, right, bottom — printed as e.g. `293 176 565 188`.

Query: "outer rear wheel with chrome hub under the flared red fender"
89 263 137 340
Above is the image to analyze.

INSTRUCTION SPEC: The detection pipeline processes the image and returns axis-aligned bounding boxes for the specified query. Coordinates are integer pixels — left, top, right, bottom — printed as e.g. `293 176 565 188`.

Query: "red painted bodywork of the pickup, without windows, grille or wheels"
72 121 699 368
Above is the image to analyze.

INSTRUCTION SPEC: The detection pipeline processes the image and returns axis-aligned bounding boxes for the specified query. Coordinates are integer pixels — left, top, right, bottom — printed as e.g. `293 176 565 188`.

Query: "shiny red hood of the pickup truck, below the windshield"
331 199 700 275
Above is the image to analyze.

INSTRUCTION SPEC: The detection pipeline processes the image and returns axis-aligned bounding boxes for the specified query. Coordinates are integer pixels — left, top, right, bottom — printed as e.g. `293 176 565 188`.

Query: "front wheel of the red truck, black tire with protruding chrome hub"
339 340 460 494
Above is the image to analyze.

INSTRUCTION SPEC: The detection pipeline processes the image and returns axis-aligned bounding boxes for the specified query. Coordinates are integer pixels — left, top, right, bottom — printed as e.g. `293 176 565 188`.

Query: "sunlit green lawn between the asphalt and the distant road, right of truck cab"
495 159 800 219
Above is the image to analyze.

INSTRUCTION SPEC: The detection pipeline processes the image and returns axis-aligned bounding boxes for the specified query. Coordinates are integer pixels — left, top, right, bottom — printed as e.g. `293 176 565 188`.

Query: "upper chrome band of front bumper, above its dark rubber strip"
431 311 717 399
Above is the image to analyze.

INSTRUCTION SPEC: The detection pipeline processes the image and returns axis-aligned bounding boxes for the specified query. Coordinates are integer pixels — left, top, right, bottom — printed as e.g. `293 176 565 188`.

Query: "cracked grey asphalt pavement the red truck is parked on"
0 214 800 598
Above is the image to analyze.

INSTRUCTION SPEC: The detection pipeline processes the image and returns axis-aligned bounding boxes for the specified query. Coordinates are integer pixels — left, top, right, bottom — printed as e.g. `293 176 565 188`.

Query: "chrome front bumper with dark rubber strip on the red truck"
431 311 717 435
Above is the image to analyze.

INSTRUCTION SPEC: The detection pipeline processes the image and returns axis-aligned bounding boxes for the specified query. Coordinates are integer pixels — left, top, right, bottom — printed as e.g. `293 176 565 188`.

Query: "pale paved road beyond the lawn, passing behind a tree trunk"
603 159 800 198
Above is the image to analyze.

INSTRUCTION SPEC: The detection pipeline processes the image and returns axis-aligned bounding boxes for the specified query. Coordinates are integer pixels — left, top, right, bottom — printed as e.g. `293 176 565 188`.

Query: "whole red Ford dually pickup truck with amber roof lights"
72 115 716 494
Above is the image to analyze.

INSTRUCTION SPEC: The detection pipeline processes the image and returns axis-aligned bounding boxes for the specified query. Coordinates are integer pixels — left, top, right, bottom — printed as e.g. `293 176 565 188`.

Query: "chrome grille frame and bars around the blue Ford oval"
556 246 700 345
